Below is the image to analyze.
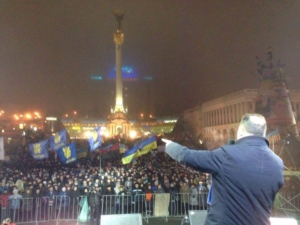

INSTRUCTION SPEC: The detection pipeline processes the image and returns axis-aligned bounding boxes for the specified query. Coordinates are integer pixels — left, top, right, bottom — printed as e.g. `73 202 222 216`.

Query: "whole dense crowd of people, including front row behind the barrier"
0 144 209 223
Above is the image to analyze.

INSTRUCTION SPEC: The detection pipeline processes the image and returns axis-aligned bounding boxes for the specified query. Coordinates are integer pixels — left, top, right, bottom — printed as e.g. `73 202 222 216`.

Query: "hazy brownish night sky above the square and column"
0 0 300 116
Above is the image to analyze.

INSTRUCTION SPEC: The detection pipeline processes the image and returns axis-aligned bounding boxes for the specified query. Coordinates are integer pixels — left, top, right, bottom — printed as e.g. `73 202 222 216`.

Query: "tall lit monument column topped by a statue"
108 10 130 138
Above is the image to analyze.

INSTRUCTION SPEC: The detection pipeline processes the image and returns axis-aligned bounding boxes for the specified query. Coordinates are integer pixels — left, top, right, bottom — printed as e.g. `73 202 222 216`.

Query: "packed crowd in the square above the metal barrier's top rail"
0 148 207 195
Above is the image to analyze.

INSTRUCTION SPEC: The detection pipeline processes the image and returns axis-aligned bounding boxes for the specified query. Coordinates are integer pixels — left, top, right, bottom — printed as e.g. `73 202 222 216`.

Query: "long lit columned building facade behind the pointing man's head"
183 89 300 149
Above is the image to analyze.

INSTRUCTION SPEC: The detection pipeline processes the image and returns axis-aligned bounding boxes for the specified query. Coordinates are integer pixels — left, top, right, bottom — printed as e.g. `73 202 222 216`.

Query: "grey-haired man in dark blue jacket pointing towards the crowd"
162 114 284 225
